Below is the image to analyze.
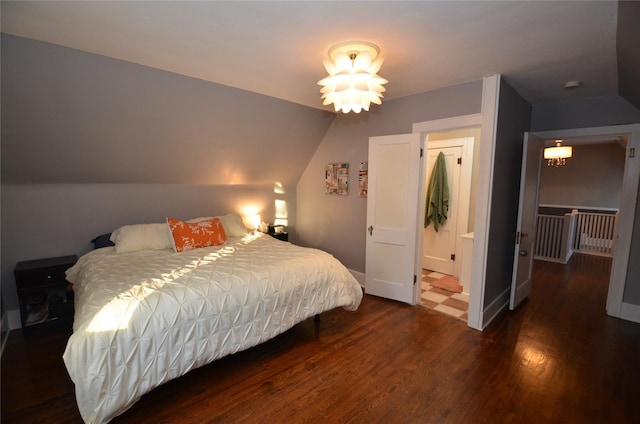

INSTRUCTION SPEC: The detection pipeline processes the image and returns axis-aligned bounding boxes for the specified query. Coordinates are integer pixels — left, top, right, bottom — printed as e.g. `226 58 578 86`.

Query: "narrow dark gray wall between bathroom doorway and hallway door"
484 79 531 308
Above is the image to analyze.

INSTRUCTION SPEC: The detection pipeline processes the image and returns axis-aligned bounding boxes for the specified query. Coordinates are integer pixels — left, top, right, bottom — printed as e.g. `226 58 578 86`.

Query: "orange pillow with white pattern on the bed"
167 218 227 252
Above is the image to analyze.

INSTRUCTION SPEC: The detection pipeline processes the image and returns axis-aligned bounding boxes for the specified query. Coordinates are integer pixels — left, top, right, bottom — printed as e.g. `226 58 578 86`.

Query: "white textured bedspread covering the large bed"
64 234 362 423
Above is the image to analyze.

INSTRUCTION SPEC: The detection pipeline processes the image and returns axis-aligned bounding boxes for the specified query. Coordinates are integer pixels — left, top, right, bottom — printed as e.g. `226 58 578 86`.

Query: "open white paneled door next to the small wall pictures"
365 134 422 303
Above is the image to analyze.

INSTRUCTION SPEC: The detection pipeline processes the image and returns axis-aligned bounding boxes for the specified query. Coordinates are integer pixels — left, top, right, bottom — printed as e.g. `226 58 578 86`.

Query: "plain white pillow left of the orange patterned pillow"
109 222 171 253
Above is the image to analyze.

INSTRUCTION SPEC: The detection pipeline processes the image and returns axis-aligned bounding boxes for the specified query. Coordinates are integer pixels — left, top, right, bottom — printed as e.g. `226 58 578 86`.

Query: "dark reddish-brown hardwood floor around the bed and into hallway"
2 256 640 424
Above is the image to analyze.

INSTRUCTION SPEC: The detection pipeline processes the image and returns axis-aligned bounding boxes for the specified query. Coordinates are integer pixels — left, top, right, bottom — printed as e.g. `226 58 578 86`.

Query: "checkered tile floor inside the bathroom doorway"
420 269 469 322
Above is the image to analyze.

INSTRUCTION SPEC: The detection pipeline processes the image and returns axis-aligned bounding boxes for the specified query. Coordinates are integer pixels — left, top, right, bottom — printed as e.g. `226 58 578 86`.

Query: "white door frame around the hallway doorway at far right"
532 124 640 322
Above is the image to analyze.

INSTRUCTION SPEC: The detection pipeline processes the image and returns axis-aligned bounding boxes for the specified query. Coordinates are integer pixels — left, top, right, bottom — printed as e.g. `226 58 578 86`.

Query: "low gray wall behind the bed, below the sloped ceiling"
0 184 296 310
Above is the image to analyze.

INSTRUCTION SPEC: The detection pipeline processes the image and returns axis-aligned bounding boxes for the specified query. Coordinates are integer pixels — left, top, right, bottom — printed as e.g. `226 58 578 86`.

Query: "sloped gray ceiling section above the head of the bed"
1 34 334 186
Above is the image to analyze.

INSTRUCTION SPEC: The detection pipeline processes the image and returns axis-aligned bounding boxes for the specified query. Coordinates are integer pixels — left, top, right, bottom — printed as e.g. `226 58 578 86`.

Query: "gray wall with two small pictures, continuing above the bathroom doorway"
296 80 482 272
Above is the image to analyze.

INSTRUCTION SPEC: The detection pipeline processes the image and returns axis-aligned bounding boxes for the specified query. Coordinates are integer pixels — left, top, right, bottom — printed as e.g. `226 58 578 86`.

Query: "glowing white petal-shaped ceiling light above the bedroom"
318 41 389 113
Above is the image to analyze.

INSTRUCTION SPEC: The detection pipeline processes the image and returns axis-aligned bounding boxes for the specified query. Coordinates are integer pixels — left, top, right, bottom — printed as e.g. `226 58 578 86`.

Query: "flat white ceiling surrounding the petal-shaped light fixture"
2 1 618 112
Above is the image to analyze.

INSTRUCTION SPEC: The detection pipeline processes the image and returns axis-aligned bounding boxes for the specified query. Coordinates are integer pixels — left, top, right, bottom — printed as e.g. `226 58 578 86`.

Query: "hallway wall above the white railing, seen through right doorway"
538 143 625 209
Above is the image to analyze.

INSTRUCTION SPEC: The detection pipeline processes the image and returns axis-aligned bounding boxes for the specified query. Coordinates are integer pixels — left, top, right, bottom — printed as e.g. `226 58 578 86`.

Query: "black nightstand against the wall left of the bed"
13 255 78 334
